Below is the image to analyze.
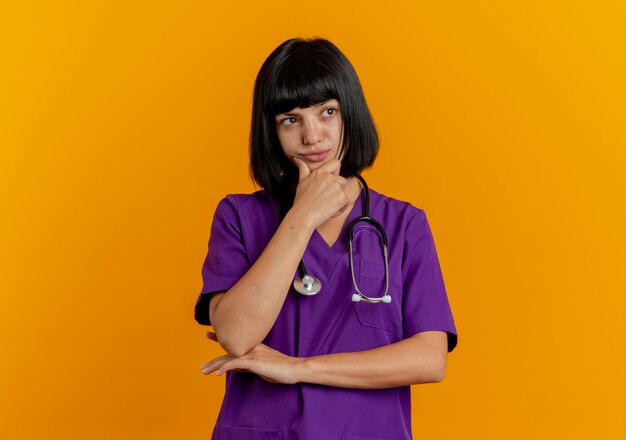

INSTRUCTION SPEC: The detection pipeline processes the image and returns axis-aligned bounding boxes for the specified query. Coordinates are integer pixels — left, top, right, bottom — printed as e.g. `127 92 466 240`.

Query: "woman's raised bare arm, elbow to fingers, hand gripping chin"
209 156 348 356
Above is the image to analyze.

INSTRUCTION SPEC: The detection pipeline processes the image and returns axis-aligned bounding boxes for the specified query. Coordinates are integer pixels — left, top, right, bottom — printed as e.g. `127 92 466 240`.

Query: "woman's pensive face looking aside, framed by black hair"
276 99 343 171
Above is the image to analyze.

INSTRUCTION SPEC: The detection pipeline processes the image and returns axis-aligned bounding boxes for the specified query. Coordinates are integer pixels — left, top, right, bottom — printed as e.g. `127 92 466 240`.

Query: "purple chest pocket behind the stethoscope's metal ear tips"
354 260 402 331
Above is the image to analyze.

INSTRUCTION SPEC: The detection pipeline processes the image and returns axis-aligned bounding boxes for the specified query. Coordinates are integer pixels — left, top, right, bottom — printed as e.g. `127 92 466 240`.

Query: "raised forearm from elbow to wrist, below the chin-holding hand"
210 210 313 356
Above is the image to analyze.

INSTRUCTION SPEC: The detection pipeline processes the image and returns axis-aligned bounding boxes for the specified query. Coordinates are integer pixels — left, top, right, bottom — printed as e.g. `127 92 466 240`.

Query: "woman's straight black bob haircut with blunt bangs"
250 38 379 197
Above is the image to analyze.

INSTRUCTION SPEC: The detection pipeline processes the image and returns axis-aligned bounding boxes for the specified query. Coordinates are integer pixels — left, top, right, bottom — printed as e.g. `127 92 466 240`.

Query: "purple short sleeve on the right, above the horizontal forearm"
402 210 457 351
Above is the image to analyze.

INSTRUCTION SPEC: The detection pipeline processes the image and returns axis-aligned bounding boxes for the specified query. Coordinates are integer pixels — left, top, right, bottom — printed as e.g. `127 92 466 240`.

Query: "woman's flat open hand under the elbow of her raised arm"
201 332 303 385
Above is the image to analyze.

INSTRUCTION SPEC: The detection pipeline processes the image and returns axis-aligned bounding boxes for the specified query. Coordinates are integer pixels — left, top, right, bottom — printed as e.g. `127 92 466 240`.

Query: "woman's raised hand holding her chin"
292 157 348 229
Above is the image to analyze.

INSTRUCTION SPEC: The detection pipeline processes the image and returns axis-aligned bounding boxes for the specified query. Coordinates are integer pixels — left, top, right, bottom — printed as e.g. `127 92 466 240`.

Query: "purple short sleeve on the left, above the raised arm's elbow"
195 196 250 325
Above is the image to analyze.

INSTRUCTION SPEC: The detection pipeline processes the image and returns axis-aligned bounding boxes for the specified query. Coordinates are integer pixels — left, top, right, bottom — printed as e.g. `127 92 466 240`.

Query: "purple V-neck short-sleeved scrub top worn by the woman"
195 190 457 440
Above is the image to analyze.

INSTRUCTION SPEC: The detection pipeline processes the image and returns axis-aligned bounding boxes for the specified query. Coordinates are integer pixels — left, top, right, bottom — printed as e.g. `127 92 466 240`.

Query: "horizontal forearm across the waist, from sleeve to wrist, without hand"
297 332 447 389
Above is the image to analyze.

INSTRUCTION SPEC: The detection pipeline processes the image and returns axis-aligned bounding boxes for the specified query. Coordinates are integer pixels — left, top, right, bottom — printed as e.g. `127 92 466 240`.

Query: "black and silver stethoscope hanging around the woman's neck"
281 174 391 304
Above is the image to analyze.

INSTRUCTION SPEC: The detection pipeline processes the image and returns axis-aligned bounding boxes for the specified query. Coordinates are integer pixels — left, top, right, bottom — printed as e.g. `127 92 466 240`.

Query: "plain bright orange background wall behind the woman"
0 0 626 440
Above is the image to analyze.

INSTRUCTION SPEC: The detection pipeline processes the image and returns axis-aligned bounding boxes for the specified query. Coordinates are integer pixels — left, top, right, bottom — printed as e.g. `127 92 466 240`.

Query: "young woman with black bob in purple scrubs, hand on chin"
195 39 457 440
